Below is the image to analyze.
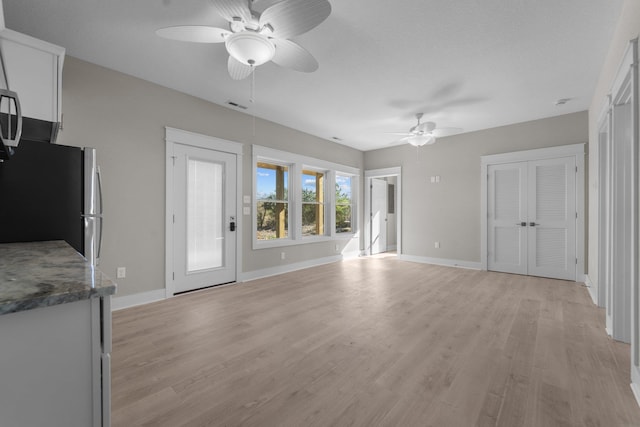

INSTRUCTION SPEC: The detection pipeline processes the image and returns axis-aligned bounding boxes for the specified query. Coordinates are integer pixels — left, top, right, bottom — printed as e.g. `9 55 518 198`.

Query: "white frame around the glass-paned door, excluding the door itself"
165 126 244 298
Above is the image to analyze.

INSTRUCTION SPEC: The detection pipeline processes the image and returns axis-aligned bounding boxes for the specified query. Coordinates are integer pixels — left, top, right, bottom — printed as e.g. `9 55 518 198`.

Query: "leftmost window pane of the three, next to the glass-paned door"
256 162 289 240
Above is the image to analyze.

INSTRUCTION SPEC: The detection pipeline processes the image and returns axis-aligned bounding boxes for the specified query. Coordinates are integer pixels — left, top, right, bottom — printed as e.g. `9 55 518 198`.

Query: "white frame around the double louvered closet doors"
480 144 585 282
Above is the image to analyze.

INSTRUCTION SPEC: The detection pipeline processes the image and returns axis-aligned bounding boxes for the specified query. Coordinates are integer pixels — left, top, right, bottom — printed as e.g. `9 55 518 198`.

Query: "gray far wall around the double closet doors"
364 111 588 262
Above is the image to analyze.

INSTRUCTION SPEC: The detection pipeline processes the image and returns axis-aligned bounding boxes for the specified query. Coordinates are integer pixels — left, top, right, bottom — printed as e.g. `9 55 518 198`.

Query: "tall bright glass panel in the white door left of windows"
187 159 224 272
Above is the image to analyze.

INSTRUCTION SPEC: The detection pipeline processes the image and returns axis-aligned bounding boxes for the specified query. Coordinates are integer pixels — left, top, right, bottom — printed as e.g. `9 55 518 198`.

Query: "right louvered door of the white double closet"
527 157 577 280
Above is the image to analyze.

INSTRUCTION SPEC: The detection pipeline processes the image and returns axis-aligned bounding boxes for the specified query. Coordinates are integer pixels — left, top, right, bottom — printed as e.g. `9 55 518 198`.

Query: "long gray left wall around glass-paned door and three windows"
58 57 363 296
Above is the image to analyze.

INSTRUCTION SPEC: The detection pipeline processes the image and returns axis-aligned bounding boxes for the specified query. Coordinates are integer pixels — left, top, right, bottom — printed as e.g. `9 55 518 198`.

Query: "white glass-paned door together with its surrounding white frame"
166 128 241 296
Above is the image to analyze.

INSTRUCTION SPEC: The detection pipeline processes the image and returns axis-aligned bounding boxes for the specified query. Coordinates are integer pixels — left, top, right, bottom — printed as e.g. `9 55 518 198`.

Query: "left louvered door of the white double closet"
487 162 528 274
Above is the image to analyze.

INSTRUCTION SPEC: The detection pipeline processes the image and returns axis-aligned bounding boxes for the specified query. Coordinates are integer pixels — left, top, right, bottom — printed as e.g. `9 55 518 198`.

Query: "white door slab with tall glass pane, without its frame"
173 144 237 293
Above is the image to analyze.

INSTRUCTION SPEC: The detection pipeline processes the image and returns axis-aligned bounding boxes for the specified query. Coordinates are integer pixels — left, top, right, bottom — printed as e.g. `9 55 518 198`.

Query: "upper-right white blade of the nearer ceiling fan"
260 0 331 39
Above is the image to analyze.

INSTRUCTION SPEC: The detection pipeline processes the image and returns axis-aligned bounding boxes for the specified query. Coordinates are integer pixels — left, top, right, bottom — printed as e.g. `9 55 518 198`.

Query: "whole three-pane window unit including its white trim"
254 145 360 249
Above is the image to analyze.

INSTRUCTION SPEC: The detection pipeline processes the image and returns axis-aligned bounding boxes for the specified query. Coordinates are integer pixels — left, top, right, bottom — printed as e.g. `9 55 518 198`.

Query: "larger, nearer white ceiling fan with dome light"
156 0 331 80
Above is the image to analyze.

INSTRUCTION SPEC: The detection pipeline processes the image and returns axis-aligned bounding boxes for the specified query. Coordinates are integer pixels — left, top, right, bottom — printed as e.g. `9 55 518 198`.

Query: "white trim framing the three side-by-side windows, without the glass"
251 145 360 249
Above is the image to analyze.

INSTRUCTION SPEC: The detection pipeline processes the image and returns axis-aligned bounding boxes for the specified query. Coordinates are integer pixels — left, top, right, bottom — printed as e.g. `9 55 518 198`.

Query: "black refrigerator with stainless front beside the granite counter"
0 139 102 265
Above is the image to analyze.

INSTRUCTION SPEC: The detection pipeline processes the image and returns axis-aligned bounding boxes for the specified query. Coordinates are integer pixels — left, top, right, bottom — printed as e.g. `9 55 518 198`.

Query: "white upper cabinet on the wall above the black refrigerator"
0 28 65 122
